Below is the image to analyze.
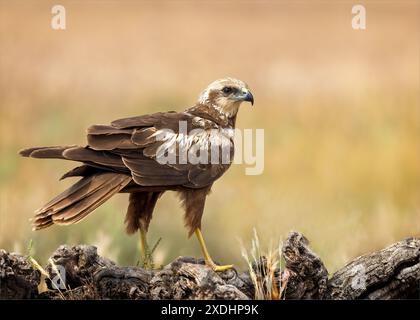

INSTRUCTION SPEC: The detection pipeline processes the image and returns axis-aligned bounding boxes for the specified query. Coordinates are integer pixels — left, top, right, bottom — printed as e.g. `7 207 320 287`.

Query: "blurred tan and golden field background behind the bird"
0 0 420 271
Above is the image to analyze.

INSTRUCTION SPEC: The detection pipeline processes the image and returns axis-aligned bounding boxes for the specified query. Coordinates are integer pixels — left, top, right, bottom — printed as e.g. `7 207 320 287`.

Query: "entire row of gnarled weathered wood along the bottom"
0 232 420 299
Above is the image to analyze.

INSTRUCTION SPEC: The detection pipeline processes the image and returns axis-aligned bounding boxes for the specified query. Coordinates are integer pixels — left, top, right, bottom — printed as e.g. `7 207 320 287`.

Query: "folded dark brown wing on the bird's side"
83 112 229 188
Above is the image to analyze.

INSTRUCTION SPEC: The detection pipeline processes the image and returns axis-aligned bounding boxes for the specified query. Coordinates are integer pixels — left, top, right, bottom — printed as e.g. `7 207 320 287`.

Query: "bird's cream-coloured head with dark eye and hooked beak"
199 78 254 118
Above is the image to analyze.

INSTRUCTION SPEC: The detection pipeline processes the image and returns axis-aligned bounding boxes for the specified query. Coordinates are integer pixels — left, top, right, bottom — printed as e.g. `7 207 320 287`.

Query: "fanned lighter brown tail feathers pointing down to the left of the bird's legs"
33 172 131 230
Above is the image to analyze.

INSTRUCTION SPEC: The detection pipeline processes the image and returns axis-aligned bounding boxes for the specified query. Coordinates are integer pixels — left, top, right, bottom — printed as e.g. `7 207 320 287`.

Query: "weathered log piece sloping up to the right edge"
326 238 420 299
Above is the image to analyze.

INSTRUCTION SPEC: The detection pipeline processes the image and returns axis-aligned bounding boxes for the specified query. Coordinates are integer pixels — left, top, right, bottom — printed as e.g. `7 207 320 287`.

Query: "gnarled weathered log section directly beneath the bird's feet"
43 245 252 299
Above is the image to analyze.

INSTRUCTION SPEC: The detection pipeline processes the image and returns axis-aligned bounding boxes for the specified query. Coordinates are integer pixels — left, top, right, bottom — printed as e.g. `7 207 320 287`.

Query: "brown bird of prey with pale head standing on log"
20 78 254 271
